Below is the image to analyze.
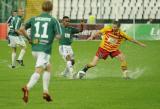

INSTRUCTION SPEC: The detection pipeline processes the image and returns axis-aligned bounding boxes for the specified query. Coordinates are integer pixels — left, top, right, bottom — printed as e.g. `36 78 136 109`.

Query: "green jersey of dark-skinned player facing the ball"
59 25 80 45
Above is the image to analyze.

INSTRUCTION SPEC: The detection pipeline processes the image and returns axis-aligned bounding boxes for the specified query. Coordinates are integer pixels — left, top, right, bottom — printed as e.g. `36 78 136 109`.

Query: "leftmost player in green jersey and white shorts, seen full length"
8 8 26 68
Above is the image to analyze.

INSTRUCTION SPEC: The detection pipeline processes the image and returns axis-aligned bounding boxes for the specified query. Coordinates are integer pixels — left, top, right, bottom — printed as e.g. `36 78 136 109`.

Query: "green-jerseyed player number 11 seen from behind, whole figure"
21 0 61 103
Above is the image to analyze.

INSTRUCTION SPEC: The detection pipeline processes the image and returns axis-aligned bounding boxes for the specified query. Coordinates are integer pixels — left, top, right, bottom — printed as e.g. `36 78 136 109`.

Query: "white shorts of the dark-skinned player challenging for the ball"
59 45 74 60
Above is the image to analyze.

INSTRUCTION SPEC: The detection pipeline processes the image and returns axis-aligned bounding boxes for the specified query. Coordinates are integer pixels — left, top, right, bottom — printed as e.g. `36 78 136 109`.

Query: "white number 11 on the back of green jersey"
34 22 48 38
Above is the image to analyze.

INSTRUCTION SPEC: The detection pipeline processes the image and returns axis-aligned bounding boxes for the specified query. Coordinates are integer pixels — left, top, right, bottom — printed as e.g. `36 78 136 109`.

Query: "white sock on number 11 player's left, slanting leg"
27 72 40 90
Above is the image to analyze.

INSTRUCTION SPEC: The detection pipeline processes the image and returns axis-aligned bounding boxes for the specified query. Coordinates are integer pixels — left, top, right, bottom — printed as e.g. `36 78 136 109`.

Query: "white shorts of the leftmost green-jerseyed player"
9 35 26 47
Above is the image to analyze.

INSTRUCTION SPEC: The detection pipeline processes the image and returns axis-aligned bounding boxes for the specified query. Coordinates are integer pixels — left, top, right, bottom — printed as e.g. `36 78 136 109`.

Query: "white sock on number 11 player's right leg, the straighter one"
43 71 51 93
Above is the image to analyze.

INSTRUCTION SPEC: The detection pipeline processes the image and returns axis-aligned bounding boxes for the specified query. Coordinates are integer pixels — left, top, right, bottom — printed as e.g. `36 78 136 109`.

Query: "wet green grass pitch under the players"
0 41 160 109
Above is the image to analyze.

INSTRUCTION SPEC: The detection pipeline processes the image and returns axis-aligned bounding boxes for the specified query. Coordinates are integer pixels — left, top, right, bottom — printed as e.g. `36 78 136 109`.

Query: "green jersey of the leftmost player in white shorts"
9 16 22 36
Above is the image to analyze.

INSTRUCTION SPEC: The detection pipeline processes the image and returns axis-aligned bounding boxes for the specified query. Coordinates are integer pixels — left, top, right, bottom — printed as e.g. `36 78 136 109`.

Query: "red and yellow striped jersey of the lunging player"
100 26 132 52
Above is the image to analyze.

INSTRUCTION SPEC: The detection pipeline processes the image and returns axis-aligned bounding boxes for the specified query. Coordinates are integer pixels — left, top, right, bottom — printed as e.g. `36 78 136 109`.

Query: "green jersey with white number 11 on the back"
25 13 61 54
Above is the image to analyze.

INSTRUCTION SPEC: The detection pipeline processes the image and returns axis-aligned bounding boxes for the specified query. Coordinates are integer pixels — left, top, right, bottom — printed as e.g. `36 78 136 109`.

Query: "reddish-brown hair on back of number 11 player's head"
42 0 53 12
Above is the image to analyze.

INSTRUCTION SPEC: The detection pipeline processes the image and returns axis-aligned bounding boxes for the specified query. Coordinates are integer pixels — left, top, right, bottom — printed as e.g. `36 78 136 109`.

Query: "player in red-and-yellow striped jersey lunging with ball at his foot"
77 21 146 79
